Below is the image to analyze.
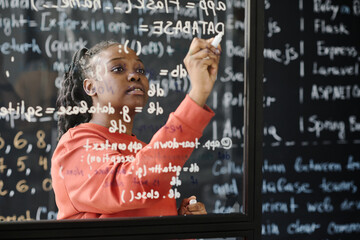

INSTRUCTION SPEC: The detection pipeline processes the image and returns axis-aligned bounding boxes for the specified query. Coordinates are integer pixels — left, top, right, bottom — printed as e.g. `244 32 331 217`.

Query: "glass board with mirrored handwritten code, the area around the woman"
0 0 245 221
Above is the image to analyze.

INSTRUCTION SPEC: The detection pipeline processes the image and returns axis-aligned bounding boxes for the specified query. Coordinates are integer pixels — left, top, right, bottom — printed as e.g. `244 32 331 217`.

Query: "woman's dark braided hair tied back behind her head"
56 41 119 139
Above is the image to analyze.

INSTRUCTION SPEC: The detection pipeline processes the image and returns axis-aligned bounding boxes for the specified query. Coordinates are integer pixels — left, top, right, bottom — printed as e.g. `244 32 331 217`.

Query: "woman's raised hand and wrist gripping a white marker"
184 38 221 107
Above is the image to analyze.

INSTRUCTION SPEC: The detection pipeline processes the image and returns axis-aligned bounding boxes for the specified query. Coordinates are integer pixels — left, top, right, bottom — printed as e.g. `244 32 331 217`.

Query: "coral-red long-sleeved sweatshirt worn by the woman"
51 96 214 219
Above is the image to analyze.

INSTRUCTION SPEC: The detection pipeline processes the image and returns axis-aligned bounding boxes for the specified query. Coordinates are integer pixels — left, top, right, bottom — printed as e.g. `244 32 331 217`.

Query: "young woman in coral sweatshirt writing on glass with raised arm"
51 38 220 219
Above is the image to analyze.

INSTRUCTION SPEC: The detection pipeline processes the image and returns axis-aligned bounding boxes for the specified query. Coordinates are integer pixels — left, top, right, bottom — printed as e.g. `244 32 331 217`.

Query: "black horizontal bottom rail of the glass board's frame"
1 217 259 240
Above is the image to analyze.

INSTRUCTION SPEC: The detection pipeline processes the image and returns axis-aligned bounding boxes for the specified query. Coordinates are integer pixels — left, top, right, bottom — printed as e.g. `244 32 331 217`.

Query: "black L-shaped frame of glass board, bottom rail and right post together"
0 0 264 237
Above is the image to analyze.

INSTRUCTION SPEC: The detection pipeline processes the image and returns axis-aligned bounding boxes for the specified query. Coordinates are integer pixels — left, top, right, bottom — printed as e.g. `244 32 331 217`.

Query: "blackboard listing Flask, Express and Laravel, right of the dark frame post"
262 0 360 240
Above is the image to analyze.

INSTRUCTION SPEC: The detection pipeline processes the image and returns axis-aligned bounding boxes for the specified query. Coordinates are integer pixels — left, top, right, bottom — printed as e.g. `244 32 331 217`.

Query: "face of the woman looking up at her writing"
91 44 149 110
